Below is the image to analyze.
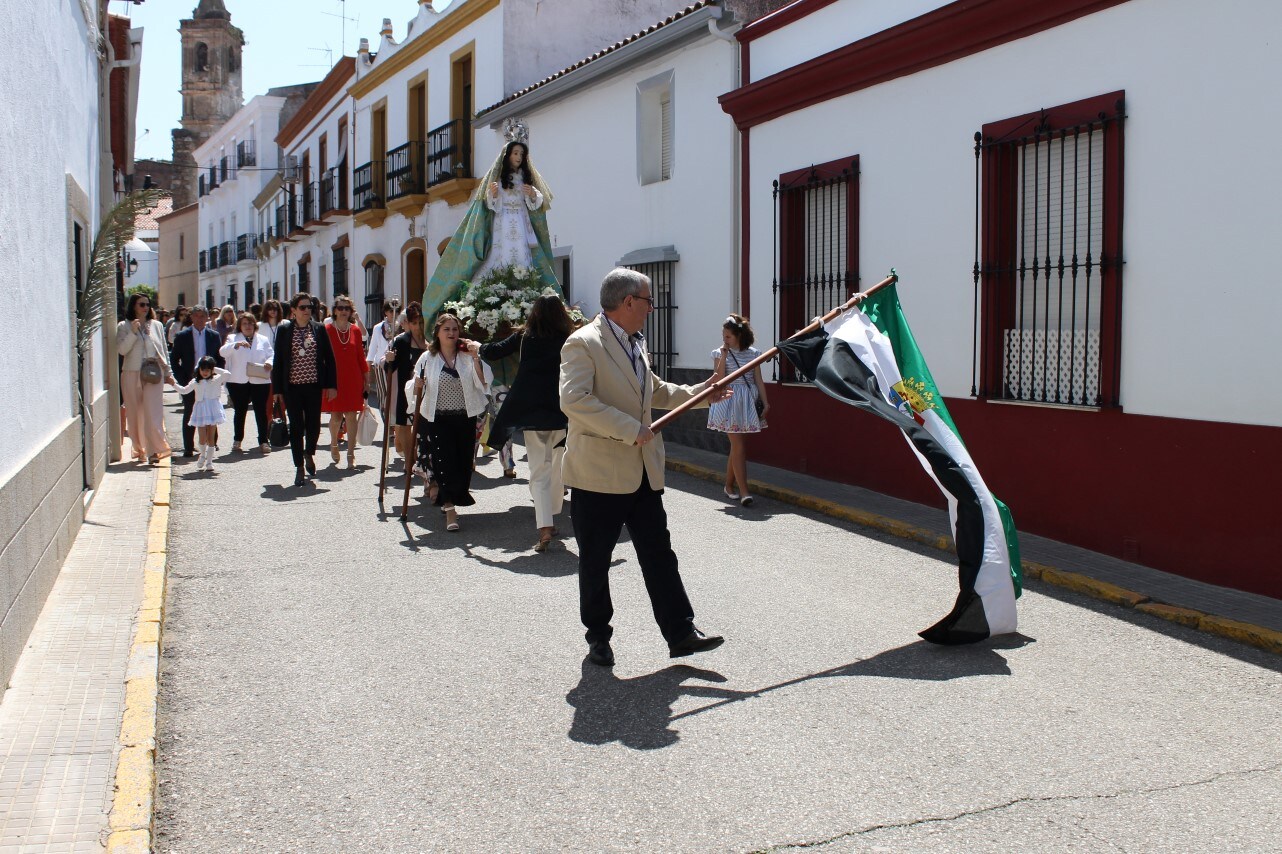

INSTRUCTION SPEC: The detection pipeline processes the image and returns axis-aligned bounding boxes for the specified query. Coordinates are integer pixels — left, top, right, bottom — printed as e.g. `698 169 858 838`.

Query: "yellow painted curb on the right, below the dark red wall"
667 459 1282 655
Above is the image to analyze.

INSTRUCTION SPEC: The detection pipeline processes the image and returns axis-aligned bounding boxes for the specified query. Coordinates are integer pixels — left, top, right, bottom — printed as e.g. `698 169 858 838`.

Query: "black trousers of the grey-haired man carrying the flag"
570 476 695 644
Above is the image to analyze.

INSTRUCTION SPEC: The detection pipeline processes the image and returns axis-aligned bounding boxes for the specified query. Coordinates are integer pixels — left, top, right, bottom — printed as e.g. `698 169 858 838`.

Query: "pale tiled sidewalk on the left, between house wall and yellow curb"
0 465 156 853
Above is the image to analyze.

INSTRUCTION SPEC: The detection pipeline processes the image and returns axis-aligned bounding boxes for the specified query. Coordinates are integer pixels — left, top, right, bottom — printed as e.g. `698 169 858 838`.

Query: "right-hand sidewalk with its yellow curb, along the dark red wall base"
664 442 1282 653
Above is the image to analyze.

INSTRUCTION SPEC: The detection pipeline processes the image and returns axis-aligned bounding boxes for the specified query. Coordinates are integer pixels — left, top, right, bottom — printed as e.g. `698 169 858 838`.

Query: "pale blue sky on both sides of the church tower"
116 0 458 160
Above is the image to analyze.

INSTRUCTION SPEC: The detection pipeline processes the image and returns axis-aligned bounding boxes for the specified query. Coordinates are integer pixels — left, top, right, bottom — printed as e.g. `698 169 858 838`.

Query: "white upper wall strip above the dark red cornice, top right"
749 0 953 82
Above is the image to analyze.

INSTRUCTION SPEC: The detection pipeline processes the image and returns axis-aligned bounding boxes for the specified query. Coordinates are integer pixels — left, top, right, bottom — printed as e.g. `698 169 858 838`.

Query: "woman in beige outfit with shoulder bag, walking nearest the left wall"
115 294 172 463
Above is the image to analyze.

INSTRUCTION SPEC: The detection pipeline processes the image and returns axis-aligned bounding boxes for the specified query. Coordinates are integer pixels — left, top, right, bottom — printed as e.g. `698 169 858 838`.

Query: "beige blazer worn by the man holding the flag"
560 315 708 495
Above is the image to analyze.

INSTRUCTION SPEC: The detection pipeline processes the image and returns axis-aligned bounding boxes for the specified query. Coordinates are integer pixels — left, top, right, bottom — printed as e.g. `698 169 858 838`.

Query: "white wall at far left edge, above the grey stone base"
0 3 103 483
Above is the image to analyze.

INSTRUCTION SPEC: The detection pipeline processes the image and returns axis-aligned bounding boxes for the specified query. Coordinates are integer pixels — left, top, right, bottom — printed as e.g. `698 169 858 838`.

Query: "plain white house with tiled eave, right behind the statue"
477 3 738 379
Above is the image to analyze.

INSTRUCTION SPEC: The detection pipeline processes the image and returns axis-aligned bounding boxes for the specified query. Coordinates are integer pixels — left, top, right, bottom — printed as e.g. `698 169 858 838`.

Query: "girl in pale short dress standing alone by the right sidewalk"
708 314 770 507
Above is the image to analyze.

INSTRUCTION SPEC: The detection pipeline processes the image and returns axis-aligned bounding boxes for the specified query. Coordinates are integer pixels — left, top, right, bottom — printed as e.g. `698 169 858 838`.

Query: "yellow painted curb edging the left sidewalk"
106 459 172 854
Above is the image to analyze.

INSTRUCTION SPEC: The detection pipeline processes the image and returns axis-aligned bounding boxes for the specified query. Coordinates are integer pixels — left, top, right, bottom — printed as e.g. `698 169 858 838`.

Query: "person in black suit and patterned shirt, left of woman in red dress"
272 294 338 486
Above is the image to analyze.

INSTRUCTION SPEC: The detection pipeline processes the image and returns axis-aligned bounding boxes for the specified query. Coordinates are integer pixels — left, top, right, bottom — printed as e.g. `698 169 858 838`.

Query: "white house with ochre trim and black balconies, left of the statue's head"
349 0 717 325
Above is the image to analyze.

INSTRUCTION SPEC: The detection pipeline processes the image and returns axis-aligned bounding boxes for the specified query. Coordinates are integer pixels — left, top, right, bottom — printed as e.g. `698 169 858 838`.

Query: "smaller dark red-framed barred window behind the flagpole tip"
772 156 859 382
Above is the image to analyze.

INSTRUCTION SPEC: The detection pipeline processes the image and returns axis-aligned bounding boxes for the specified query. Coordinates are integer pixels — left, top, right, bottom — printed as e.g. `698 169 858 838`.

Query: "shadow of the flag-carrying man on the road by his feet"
565 659 751 750
